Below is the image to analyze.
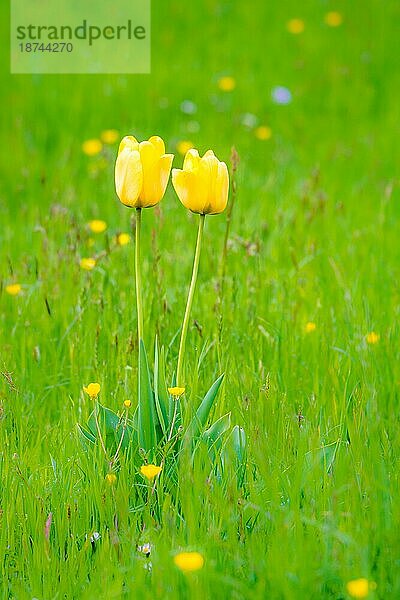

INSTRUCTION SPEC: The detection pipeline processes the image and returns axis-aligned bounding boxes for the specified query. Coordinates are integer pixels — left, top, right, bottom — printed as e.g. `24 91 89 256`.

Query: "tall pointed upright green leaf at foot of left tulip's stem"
138 340 157 452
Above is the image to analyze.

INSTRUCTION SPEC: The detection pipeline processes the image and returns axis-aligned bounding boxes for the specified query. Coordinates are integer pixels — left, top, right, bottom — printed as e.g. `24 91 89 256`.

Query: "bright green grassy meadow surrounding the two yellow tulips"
0 0 400 600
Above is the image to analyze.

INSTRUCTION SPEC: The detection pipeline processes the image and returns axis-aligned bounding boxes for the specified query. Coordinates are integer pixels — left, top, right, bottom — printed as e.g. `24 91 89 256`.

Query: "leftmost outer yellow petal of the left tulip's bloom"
115 147 143 208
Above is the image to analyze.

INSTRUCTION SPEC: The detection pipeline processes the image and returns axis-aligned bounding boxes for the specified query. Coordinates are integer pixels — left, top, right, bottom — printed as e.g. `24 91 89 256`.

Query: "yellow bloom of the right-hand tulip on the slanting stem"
172 149 229 215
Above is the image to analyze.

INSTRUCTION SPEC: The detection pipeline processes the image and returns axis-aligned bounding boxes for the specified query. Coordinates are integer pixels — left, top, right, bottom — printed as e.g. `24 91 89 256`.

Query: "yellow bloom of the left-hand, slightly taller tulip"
115 135 174 208
